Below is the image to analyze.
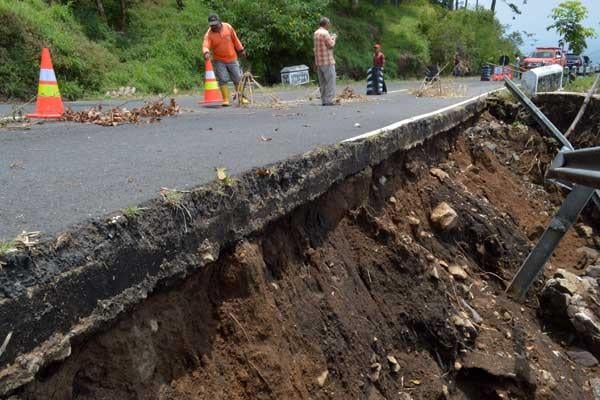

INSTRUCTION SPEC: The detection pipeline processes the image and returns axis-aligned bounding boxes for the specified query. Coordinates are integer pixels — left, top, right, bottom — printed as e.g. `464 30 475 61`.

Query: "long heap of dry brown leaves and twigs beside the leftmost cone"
61 99 181 126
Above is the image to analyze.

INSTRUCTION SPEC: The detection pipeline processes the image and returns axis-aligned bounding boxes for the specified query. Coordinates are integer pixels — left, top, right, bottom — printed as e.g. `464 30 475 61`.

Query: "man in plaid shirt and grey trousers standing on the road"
313 17 337 106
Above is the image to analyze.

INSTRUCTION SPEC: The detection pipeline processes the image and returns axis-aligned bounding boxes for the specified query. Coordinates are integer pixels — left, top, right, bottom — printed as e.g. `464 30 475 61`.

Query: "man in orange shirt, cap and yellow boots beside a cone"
202 14 246 106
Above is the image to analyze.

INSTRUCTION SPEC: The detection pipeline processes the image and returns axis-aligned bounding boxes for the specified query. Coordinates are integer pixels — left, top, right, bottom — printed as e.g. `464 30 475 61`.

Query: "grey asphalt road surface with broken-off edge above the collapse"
0 79 500 239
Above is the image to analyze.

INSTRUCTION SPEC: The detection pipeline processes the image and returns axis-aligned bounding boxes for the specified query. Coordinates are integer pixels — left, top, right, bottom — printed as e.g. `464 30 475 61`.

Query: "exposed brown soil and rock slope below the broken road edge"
18 99 597 400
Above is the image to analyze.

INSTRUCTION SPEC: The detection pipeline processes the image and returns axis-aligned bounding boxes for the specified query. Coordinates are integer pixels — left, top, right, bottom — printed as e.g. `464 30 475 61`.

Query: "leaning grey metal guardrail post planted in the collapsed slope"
507 186 594 301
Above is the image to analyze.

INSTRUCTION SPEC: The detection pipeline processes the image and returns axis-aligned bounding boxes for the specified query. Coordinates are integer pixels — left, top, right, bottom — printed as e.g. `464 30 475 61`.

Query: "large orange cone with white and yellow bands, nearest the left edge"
27 48 65 118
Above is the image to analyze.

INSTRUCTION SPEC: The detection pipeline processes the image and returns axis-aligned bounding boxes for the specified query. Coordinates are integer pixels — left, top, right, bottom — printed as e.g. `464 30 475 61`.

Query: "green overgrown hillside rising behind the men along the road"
0 0 515 99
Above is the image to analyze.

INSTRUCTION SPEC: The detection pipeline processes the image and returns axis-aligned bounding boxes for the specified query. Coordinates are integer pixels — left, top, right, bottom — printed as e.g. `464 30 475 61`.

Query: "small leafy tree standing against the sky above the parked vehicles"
546 0 596 54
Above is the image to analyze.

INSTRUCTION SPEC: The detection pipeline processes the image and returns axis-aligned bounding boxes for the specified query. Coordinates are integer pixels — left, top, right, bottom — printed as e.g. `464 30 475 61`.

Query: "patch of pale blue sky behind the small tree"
476 0 600 62
